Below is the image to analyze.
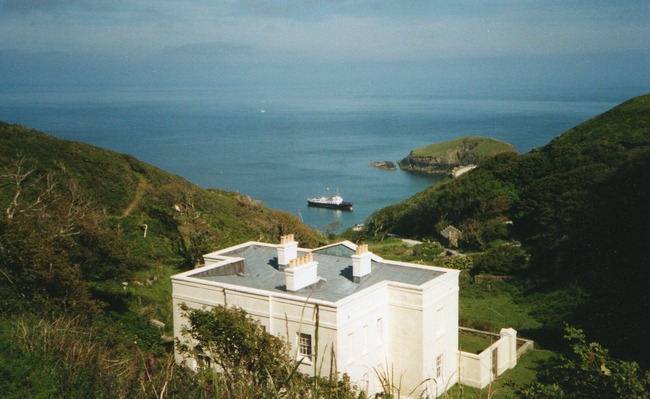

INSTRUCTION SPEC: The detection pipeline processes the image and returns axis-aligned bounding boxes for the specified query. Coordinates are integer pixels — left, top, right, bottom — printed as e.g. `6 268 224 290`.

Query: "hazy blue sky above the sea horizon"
0 0 650 91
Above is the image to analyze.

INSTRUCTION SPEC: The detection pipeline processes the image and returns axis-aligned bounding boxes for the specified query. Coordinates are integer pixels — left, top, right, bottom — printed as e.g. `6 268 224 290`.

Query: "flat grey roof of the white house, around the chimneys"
190 243 444 302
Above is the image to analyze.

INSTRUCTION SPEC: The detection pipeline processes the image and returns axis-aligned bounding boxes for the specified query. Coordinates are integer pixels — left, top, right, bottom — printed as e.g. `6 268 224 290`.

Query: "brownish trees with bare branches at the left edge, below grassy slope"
0 157 139 315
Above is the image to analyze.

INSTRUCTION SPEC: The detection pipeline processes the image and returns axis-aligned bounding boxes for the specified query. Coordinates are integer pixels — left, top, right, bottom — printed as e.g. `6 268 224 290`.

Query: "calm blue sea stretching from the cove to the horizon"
0 86 643 230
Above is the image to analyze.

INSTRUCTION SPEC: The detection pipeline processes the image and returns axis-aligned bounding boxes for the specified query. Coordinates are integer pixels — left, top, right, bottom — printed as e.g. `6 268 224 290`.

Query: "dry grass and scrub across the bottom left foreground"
0 315 359 399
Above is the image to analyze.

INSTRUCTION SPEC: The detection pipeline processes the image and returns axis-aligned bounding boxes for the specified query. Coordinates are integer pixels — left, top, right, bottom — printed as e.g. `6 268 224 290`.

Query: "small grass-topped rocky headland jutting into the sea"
398 136 516 174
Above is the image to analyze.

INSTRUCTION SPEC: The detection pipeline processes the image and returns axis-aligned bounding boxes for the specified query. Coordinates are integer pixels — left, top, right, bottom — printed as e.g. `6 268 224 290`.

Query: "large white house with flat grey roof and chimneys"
172 235 516 396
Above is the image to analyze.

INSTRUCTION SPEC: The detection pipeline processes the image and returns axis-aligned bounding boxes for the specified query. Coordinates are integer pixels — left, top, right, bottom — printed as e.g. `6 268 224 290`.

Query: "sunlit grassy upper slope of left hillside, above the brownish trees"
0 122 322 247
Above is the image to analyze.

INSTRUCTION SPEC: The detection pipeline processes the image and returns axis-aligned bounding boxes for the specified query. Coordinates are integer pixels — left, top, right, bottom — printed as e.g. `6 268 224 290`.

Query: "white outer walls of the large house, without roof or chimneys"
172 244 460 396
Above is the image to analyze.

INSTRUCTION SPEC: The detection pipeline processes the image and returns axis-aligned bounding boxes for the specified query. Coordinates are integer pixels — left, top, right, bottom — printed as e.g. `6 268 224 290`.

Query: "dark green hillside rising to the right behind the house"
366 95 650 366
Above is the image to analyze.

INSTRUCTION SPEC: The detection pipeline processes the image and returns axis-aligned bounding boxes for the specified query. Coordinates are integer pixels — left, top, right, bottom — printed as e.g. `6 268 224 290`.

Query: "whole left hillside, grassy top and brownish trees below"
0 122 322 314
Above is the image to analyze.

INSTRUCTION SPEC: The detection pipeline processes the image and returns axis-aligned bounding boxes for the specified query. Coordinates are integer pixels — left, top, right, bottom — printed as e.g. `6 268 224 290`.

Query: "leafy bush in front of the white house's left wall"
180 305 357 399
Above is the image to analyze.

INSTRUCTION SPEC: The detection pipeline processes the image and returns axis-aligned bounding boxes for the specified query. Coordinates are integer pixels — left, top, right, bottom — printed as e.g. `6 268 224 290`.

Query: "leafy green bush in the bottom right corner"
517 326 650 399
